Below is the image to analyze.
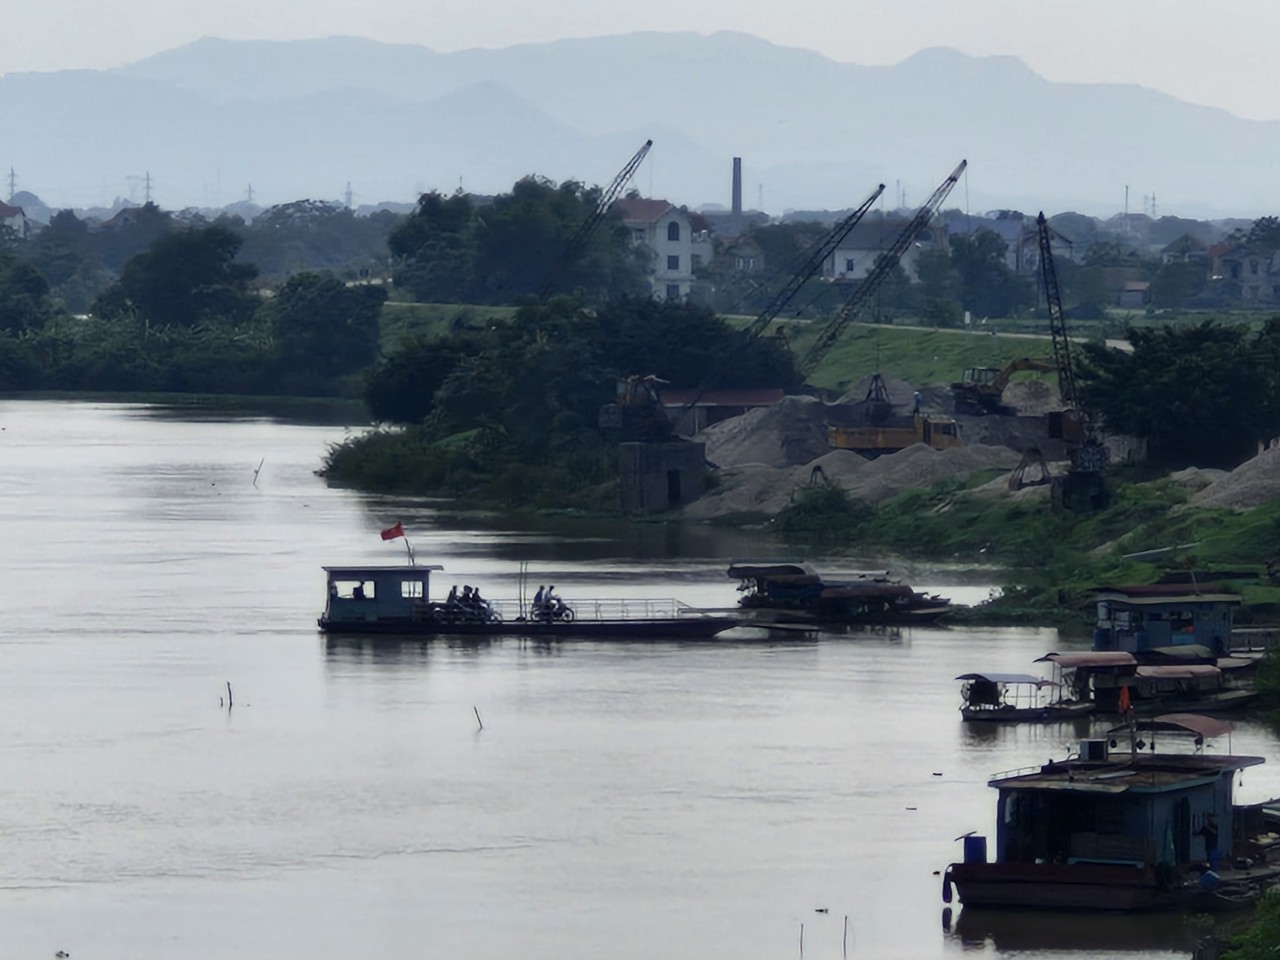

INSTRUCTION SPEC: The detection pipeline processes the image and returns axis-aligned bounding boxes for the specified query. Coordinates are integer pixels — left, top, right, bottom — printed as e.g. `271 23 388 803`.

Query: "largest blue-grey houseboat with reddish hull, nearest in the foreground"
943 713 1280 911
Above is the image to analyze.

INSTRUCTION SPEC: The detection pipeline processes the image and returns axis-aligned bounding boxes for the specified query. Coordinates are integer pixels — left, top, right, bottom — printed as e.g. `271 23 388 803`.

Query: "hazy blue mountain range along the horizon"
0 33 1280 218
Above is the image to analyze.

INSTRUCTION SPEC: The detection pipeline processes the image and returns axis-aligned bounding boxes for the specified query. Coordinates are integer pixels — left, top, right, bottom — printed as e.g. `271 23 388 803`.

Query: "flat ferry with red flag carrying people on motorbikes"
317 563 741 640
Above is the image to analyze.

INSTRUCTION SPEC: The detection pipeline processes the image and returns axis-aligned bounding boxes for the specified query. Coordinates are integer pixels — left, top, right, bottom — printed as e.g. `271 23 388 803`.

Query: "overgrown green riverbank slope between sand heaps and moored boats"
778 476 1280 625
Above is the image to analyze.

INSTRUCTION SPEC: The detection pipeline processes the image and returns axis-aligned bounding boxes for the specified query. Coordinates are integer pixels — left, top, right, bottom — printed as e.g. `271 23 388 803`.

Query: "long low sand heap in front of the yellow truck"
684 444 1021 520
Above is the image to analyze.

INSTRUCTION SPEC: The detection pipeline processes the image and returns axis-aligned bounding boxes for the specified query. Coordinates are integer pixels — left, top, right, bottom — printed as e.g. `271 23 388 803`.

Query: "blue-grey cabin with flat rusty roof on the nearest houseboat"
989 714 1263 870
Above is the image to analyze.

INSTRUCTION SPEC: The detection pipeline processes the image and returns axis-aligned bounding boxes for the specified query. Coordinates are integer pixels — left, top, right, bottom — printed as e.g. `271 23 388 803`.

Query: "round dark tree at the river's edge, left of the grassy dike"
260 273 387 380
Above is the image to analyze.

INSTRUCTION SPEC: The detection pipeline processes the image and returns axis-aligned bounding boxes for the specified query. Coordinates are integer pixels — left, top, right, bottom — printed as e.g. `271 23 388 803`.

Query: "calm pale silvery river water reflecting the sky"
0 401 1280 960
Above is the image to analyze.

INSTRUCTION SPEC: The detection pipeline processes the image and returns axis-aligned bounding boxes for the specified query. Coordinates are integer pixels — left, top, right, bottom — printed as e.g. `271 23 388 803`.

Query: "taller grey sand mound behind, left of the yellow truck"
694 397 831 467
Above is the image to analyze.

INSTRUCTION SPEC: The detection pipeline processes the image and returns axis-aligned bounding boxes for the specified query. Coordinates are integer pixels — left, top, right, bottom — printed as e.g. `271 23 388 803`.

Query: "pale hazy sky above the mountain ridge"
10 0 1280 119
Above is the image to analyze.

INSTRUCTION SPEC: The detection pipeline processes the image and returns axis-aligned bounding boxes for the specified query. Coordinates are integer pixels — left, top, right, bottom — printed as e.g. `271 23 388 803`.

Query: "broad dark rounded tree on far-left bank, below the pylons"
93 227 259 326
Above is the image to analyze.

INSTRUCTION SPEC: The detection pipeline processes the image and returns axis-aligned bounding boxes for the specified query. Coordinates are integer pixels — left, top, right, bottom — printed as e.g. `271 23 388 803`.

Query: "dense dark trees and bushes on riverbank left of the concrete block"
326 298 799 506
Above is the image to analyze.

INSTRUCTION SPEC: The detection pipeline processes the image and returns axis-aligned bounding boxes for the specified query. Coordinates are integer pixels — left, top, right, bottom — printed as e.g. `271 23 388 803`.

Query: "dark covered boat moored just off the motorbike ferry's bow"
728 561 951 626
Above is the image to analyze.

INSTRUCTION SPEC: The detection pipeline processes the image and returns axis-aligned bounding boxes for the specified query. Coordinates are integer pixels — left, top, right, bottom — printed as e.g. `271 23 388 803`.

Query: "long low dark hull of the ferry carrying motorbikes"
319 617 740 640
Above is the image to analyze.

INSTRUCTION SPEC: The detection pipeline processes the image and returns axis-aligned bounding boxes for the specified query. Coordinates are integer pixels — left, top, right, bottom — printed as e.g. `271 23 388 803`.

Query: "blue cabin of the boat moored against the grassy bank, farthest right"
1093 584 1240 657
